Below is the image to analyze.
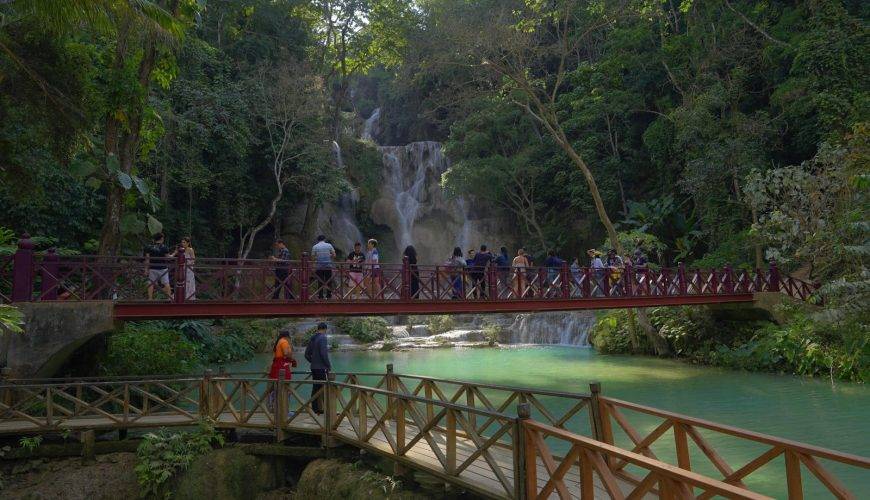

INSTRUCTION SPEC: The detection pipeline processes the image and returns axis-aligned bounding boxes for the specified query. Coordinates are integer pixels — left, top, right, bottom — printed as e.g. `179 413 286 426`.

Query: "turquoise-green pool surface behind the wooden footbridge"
226 346 870 498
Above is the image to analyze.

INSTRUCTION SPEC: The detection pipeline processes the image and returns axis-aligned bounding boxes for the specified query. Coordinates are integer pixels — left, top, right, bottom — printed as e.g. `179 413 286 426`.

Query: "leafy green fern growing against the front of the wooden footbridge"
134 420 224 498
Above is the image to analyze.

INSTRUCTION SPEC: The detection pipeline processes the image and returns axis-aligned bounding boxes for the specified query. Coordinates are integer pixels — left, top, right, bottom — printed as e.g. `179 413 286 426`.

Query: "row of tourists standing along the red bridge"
145 233 647 300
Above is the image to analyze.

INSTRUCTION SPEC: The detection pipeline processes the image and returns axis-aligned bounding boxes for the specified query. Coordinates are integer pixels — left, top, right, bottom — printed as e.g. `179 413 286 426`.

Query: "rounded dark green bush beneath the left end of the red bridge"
101 323 202 375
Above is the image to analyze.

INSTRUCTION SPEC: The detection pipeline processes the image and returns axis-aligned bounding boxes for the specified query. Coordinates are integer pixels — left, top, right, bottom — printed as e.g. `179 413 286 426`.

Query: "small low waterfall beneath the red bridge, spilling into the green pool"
506 312 595 347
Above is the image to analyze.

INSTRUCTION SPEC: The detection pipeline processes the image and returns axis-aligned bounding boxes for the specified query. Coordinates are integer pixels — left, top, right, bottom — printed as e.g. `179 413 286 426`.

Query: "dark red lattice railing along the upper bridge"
0 235 815 303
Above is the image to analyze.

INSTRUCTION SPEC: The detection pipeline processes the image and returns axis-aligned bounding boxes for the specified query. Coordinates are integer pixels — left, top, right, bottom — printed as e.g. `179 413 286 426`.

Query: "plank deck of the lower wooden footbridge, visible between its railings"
0 411 640 499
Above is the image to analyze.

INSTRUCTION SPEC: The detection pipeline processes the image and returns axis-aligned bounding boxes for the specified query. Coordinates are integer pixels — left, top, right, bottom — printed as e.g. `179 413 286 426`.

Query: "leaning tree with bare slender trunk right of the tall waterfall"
442 0 670 355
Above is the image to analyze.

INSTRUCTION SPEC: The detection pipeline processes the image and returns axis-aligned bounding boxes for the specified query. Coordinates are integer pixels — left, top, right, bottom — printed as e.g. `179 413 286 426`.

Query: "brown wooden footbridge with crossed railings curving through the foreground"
0 365 870 500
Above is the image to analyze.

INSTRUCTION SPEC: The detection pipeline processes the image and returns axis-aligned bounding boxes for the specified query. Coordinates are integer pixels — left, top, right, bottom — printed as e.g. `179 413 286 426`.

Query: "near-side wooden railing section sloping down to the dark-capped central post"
327 382 521 498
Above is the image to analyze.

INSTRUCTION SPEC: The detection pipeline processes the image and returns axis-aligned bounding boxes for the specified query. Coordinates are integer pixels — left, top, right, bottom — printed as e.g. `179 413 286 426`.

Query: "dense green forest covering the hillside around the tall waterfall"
0 0 870 380
